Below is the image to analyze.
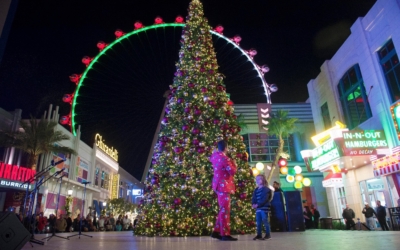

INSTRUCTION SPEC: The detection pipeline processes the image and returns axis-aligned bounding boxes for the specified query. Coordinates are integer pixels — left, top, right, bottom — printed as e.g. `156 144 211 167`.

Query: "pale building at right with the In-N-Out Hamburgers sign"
303 0 400 224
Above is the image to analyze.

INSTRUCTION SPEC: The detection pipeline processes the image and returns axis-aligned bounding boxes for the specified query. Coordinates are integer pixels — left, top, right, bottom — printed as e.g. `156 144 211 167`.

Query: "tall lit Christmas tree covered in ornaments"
135 0 255 236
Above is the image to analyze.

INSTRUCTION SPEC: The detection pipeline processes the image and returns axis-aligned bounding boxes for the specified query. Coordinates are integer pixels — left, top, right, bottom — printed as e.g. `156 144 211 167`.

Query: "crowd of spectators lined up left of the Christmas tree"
17 213 137 234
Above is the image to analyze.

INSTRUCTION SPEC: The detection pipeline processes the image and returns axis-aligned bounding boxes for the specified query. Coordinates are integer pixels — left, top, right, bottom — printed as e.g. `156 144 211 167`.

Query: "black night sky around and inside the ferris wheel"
0 0 375 179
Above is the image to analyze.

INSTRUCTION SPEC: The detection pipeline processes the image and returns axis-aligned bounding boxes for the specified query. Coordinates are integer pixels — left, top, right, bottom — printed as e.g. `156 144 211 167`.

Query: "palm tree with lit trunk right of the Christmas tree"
265 110 298 182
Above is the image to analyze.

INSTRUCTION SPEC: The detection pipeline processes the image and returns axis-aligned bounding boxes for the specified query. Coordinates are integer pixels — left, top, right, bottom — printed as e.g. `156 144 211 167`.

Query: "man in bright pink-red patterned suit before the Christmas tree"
210 141 237 241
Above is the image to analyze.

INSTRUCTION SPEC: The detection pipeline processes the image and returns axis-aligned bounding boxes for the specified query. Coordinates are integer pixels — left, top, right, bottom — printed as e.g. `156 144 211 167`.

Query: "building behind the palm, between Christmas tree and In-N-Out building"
234 103 329 217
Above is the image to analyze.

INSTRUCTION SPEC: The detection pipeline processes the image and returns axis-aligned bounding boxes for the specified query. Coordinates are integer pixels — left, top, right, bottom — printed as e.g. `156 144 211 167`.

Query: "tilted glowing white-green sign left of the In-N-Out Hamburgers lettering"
311 139 341 169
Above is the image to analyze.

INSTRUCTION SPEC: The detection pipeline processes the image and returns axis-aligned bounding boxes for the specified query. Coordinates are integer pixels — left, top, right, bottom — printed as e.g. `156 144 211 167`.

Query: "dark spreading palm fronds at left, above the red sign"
0 116 76 169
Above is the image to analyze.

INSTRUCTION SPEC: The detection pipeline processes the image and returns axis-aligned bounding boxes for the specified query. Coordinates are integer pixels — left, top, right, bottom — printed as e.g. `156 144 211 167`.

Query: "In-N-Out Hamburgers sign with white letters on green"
343 130 388 149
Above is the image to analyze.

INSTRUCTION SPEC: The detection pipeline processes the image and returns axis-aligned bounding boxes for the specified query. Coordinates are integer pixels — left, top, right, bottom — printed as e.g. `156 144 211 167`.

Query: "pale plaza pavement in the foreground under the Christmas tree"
23 230 400 250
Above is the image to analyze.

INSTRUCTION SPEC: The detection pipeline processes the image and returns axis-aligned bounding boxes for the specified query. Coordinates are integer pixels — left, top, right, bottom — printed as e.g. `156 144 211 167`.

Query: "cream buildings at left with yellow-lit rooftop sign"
0 103 142 217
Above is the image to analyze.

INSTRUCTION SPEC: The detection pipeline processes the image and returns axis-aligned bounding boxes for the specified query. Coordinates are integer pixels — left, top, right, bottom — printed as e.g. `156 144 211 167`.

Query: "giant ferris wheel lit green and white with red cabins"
60 16 278 135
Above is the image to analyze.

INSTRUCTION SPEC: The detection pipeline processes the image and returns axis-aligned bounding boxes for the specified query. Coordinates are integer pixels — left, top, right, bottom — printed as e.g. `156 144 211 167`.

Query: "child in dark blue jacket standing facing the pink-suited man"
252 175 273 240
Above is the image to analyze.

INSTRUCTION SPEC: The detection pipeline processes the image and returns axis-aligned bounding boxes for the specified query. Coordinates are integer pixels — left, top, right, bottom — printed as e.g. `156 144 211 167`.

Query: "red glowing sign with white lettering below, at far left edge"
0 163 36 189
